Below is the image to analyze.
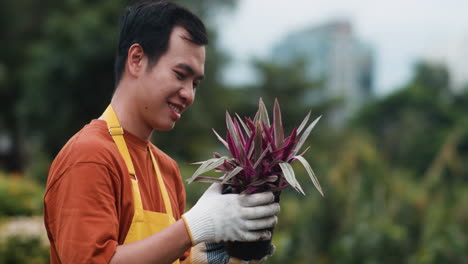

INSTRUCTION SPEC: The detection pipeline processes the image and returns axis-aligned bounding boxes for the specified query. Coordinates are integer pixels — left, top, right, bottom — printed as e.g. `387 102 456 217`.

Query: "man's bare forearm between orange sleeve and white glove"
110 219 192 264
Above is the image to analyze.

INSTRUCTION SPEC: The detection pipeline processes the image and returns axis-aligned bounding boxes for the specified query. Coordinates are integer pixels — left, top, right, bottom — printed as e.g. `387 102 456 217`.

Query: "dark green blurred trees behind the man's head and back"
0 0 235 178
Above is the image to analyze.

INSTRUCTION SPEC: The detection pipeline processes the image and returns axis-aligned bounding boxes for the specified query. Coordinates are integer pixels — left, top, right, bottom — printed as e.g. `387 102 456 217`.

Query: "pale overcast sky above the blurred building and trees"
218 0 468 94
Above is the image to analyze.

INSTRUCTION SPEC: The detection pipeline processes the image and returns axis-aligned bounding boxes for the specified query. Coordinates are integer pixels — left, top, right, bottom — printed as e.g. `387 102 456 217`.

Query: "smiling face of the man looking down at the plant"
135 27 205 130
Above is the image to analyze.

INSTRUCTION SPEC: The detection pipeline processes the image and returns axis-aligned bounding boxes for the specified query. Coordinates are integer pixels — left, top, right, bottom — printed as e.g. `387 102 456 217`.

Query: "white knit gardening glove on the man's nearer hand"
182 183 280 245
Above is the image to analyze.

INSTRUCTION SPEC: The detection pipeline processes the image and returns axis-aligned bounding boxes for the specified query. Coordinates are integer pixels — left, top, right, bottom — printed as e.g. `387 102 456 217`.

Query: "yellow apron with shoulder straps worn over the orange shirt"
103 105 179 264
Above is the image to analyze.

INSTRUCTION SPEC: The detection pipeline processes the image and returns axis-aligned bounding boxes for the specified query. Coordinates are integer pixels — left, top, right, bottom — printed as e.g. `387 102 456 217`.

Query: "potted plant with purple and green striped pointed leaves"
188 98 323 260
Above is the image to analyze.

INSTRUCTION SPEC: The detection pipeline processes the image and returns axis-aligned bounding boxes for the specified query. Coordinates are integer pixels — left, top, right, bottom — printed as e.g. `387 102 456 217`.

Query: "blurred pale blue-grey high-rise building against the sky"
272 21 374 125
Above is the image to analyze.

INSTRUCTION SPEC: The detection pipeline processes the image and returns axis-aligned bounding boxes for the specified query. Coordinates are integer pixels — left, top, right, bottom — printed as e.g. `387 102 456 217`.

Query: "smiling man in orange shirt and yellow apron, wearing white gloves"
44 1 279 263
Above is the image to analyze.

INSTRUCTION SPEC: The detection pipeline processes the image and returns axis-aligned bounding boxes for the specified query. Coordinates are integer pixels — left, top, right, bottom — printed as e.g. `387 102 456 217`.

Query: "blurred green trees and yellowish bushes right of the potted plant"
271 60 468 264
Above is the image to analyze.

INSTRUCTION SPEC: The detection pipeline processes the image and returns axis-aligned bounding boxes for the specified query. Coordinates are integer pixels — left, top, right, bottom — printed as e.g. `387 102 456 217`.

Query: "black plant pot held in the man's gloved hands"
224 192 281 261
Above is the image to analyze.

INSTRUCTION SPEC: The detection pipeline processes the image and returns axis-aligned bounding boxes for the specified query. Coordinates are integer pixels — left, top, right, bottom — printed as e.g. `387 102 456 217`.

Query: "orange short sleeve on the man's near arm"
44 163 119 263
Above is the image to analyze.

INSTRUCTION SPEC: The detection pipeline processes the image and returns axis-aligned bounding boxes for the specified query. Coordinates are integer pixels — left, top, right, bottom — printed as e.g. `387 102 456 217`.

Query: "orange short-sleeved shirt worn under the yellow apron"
44 120 187 264
